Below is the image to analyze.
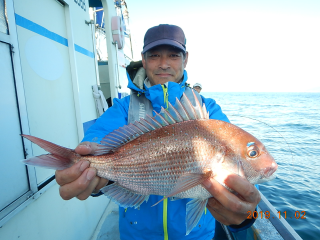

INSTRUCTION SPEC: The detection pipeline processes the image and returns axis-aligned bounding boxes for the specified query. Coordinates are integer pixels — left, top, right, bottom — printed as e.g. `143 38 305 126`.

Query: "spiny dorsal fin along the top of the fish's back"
99 89 209 155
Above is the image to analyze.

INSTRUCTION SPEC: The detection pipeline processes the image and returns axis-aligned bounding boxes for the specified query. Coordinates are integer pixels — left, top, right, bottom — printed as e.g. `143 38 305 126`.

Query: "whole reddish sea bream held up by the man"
23 91 277 234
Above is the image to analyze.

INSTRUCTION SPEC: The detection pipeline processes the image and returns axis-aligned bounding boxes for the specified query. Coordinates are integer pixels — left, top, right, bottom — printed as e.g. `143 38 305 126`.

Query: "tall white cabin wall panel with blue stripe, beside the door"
14 0 78 183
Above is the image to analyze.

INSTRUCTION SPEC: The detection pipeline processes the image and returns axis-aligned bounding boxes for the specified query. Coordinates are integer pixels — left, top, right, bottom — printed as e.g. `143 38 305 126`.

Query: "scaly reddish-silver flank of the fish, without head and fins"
88 120 231 198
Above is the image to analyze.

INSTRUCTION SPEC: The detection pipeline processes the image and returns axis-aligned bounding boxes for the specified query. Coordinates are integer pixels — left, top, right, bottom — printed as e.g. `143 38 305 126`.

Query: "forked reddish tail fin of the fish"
21 134 81 170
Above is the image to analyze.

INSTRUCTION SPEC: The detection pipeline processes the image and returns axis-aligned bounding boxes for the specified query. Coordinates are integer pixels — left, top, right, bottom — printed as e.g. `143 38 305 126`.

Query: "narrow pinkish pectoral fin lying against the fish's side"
152 171 212 207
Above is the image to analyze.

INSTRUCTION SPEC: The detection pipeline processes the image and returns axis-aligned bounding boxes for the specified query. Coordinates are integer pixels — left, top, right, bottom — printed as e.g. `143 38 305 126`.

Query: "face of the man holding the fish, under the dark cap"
142 45 188 86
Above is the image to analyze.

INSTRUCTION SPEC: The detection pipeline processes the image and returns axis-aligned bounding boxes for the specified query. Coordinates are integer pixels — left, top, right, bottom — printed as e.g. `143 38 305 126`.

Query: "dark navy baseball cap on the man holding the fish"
142 24 186 53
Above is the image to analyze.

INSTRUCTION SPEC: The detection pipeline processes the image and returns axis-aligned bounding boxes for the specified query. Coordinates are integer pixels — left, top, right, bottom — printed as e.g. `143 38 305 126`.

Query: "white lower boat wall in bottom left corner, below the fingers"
0 184 109 240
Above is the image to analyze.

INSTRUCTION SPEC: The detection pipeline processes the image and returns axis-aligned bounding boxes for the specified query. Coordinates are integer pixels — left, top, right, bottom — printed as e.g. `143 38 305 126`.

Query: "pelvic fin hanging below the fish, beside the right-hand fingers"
186 199 208 235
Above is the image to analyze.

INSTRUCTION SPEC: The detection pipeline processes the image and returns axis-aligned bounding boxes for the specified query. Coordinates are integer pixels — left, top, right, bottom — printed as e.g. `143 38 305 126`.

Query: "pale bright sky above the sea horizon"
126 0 320 92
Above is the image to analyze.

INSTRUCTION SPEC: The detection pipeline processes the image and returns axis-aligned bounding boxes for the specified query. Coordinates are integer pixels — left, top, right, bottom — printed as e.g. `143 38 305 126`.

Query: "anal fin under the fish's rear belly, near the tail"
101 183 149 208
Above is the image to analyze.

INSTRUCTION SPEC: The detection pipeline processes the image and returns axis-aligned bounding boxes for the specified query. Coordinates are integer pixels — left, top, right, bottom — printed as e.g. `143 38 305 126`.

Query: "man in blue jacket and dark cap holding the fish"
56 24 260 239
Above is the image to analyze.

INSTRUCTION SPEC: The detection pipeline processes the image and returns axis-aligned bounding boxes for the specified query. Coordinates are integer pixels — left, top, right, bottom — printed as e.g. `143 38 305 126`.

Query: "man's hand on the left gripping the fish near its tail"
56 142 109 200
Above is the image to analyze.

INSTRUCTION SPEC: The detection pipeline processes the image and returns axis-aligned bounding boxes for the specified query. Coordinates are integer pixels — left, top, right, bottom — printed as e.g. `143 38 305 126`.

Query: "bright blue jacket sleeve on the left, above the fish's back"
82 96 130 143
